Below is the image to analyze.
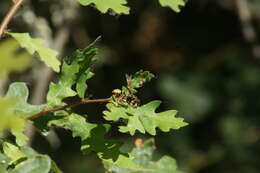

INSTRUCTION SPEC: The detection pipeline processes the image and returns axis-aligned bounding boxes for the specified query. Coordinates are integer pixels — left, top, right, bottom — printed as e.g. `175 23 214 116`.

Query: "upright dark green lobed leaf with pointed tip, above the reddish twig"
47 37 100 107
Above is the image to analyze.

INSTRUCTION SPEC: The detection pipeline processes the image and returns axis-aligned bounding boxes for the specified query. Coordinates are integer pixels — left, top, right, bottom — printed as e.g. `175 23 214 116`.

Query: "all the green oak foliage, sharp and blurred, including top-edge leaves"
0 0 187 173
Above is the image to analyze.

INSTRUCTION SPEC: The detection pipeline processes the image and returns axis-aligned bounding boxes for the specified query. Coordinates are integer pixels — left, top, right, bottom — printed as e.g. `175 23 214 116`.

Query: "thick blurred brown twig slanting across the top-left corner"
0 0 24 38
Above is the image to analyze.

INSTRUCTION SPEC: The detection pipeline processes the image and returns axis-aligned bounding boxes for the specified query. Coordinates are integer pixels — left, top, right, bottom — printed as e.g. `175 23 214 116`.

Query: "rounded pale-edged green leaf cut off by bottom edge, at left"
10 155 51 173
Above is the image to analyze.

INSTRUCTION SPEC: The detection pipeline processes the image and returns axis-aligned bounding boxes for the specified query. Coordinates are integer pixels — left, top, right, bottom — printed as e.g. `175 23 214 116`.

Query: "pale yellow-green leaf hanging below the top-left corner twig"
8 32 60 72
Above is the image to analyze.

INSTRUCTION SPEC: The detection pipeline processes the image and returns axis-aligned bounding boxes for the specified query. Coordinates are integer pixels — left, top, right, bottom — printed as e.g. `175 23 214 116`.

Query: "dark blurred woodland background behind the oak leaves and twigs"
0 0 260 173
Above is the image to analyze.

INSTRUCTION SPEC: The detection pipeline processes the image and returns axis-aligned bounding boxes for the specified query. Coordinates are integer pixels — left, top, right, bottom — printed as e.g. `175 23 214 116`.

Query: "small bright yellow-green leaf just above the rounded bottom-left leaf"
3 142 26 163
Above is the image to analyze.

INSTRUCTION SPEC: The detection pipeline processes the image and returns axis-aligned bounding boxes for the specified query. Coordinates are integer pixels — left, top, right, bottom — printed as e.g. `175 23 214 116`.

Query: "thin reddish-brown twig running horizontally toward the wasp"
25 98 110 120
